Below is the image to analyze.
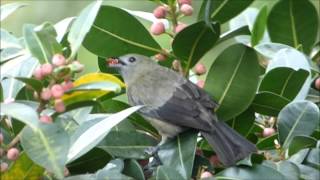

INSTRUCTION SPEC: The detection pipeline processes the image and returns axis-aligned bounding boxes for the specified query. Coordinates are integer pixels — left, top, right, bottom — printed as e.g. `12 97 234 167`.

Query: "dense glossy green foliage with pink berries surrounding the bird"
0 0 320 180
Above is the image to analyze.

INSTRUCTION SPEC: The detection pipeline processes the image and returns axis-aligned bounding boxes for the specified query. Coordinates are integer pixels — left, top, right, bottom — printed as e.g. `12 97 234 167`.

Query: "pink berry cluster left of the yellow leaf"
33 54 84 123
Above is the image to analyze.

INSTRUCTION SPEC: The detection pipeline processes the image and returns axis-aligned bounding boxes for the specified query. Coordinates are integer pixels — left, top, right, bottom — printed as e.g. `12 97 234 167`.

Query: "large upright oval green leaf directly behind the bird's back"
205 44 260 120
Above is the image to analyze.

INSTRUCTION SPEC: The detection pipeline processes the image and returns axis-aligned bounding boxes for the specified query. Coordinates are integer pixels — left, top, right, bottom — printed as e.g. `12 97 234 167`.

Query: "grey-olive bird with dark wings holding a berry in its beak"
108 54 257 166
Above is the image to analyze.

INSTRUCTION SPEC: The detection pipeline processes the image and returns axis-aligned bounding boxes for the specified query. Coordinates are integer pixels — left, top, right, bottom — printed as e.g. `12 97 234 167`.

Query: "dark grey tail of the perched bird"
201 121 257 166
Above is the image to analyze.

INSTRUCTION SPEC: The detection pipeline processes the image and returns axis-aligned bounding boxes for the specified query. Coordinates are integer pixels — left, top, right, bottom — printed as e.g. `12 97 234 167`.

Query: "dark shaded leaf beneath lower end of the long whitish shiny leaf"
67 148 111 174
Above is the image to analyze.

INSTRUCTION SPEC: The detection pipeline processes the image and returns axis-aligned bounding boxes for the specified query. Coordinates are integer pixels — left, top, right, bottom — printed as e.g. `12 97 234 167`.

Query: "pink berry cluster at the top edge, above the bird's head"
150 0 193 35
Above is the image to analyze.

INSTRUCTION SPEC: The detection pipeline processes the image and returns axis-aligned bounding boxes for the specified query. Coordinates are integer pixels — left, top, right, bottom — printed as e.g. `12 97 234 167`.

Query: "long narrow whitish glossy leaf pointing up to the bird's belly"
68 106 142 162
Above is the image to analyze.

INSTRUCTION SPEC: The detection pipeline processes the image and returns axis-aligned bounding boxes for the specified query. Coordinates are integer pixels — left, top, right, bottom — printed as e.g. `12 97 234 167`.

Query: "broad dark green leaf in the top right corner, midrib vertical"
267 0 319 54
